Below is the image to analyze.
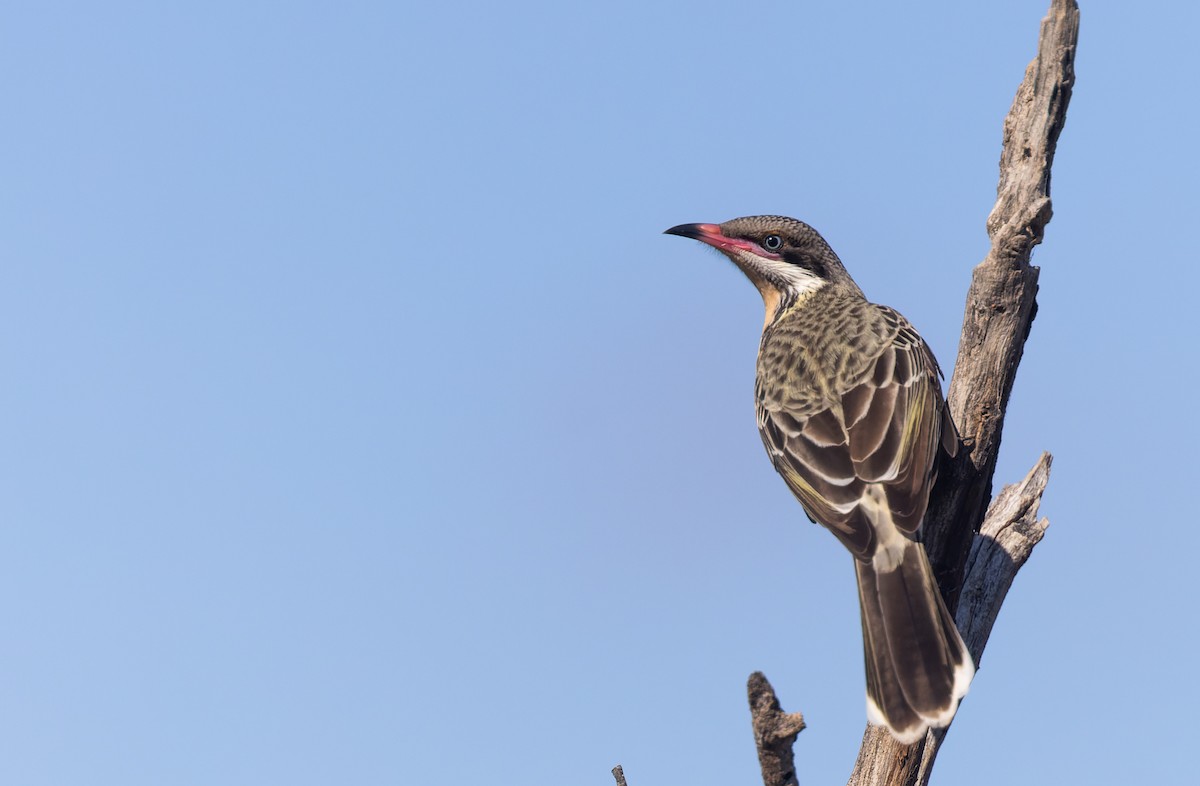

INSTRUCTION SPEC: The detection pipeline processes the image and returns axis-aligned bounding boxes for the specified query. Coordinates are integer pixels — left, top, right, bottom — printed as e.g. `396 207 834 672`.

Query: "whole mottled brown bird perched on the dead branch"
665 216 974 744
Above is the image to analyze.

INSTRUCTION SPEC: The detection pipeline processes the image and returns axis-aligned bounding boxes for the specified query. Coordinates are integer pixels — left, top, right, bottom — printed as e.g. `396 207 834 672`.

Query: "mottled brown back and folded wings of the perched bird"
755 291 956 557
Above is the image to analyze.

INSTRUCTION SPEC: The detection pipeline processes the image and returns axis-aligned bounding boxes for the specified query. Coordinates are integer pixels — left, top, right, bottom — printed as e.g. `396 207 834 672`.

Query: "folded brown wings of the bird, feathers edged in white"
758 307 956 557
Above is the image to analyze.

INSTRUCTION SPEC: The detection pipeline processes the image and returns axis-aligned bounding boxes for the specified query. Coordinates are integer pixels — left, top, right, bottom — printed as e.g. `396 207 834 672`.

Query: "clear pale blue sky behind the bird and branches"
0 0 1200 786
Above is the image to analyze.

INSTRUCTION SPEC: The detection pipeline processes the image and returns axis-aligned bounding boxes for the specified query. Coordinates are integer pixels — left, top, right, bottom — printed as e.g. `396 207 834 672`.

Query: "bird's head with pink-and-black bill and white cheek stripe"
665 216 857 319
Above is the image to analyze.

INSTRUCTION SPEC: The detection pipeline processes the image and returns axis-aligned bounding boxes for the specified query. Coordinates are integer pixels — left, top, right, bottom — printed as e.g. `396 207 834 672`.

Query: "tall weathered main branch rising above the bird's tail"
923 0 1079 597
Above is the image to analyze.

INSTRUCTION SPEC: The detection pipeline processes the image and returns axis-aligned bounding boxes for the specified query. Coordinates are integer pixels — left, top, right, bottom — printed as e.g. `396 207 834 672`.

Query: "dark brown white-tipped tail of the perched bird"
854 541 974 744
